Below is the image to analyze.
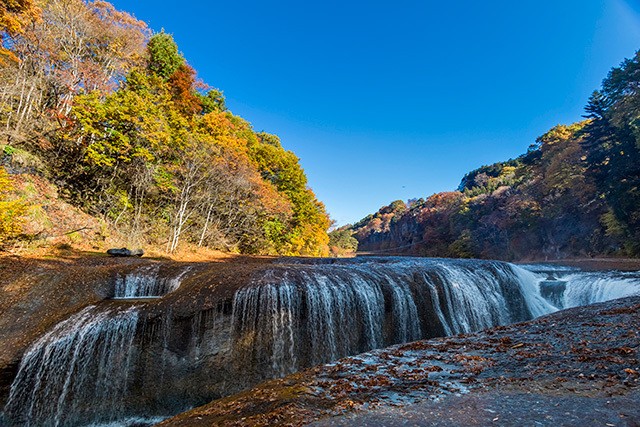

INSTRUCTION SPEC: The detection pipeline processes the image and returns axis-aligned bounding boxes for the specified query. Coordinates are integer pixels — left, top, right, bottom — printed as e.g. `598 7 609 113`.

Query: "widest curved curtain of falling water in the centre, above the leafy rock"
232 258 555 376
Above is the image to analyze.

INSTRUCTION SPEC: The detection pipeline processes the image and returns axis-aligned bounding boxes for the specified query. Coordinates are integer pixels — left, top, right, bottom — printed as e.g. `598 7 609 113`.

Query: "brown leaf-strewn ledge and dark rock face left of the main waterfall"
0 257 271 420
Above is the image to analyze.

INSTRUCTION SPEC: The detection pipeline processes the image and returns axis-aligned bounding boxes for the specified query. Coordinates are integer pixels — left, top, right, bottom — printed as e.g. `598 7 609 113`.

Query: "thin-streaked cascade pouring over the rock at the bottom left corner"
5 306 138 426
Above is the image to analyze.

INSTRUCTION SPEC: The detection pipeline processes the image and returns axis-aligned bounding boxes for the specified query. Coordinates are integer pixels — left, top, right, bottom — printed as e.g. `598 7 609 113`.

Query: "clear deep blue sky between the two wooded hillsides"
112 0 640 224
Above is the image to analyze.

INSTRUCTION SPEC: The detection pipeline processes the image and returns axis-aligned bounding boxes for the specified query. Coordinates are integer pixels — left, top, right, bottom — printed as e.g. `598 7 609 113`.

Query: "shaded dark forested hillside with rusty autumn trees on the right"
350 53 640 260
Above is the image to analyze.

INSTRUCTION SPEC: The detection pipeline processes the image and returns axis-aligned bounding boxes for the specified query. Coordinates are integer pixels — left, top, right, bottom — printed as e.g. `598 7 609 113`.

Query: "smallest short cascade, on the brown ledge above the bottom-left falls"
114 265 189 299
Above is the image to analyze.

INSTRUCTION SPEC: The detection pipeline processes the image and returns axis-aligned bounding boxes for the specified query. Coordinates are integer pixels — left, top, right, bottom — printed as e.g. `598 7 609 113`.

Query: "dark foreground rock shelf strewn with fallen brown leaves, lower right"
161 297 640 426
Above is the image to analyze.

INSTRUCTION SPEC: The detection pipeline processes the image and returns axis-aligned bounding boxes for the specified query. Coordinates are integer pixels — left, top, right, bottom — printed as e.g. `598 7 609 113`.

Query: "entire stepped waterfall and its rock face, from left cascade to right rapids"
0 258 640 426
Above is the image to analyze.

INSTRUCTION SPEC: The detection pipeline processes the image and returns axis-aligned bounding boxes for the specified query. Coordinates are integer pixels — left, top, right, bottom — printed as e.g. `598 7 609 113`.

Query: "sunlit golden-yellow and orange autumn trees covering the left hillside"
0 0 329 255
